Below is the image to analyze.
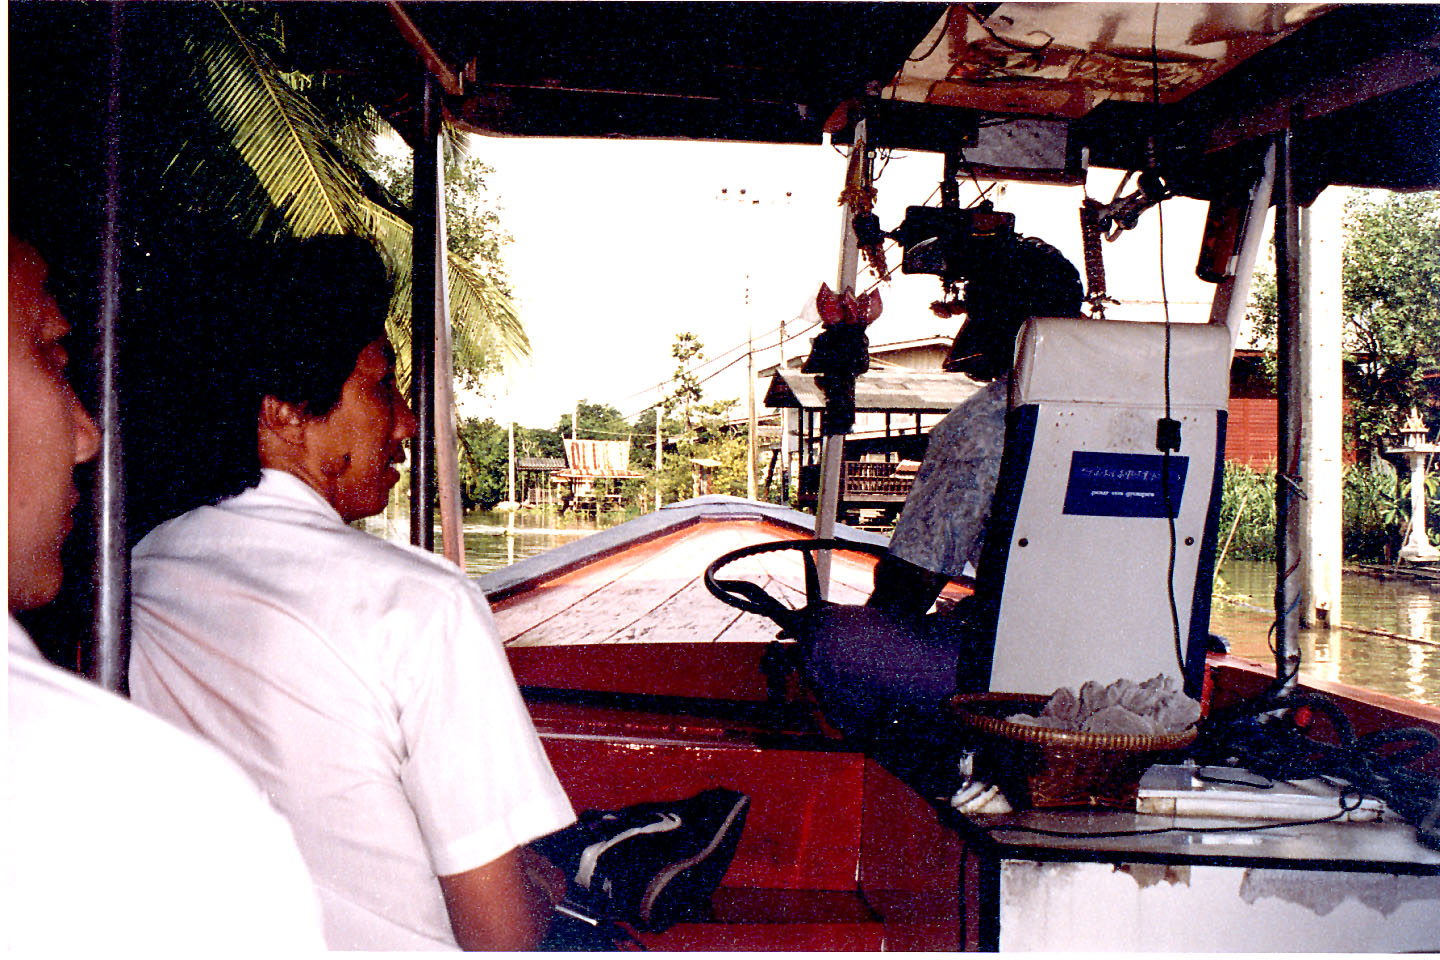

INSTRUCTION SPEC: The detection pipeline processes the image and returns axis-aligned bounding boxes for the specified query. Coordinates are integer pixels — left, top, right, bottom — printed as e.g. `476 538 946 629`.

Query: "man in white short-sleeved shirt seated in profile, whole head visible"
131 237 746 950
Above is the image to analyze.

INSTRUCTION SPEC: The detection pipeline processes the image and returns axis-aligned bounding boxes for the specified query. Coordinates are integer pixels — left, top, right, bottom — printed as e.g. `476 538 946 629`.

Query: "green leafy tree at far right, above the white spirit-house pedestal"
1247 191 1440 452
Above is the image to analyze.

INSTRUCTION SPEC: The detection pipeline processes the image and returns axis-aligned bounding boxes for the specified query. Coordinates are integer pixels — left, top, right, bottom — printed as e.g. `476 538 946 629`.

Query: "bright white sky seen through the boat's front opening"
462 138 1214 427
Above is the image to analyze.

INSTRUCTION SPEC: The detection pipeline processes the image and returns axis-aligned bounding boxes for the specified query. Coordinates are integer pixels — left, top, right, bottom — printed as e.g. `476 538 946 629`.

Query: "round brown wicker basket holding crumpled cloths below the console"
952 694 1195 809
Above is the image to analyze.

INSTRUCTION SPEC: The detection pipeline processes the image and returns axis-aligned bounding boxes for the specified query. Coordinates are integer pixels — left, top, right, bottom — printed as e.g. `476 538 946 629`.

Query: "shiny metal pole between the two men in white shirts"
81 3 130 695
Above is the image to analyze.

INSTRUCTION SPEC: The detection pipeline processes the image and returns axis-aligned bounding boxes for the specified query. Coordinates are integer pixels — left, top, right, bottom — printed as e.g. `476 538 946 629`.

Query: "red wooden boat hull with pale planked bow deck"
480 497 1440 950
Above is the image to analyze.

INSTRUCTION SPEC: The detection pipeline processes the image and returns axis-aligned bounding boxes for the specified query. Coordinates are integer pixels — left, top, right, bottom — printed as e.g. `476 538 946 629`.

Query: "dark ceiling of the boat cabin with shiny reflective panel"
285 1 1440 197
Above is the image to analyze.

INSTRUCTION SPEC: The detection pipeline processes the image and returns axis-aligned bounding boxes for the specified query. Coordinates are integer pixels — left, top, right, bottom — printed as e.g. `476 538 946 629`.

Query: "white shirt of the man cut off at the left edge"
3 619 324 957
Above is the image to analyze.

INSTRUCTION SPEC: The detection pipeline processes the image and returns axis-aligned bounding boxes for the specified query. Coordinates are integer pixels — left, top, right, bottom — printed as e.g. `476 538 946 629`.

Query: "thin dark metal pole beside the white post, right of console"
1274 128 1302 694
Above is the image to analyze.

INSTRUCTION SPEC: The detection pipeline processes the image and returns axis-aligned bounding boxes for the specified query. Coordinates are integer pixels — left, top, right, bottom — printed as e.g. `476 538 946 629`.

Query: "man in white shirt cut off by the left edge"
4 235 324 956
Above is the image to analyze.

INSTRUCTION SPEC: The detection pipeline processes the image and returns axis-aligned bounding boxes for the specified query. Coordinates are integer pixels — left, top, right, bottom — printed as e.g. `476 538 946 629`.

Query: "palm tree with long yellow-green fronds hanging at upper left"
166 0 530 380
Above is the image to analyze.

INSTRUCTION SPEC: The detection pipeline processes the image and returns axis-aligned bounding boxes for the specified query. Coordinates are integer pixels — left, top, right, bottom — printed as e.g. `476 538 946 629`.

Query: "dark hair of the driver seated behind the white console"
945 236 1084 380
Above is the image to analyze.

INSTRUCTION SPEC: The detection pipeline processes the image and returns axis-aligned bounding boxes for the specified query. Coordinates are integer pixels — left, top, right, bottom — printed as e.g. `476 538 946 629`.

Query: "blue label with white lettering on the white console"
1064 450 1189 517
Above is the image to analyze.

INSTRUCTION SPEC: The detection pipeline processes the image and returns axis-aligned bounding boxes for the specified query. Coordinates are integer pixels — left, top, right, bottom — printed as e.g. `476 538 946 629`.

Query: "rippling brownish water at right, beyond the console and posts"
1210 560 1440 707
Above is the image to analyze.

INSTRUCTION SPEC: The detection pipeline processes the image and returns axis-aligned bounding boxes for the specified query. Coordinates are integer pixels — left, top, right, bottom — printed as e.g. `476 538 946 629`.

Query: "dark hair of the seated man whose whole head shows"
248 236 393 416
